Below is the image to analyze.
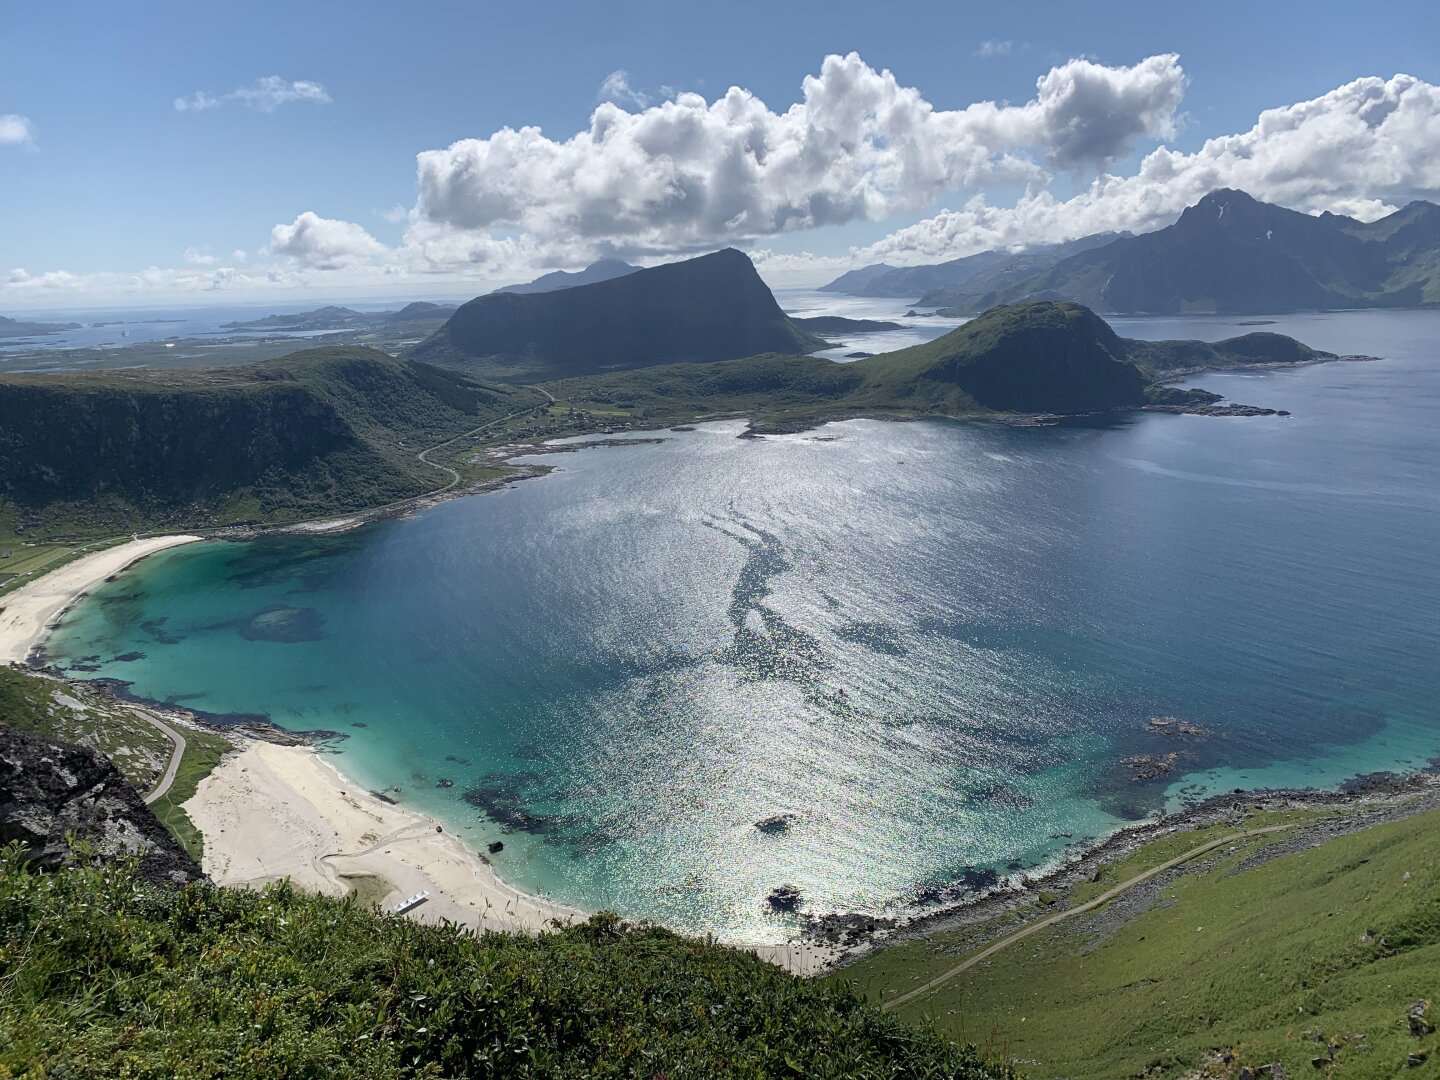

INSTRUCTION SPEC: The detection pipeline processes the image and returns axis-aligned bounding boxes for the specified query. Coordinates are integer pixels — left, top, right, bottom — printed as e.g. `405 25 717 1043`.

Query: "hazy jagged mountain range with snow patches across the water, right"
824 189 1440 315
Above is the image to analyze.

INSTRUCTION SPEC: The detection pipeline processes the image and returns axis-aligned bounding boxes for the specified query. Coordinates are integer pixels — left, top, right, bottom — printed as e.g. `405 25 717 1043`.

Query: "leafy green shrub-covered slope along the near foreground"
0 850 992 1080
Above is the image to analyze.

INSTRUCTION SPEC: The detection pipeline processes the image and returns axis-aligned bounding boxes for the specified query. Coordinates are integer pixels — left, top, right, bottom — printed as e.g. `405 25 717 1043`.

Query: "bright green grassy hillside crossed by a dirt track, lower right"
842 811 1440 1080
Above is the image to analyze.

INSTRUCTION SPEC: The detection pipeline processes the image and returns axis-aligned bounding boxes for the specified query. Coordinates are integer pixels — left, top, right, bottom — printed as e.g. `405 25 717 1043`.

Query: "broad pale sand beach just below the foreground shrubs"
184 740 585 930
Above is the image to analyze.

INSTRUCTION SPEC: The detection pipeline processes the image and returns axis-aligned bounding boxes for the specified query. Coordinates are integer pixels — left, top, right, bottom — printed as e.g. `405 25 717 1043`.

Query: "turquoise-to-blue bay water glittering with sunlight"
49 312 1440 940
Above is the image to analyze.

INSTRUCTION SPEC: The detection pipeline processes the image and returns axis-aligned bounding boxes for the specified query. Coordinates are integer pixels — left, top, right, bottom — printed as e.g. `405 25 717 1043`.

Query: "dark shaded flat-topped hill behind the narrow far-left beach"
0 347 544 536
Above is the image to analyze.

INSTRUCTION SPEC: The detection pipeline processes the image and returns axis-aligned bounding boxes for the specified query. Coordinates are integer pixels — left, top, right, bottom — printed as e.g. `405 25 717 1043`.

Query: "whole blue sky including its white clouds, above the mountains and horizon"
0 0 1440 314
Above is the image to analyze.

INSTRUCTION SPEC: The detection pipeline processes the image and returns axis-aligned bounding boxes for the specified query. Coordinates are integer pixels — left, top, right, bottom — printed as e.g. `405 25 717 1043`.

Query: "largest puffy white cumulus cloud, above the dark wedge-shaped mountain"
416 53 1185 252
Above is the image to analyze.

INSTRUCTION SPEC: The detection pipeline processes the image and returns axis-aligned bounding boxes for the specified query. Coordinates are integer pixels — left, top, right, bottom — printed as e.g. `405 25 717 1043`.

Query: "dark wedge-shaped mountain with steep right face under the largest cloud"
413 248 825 382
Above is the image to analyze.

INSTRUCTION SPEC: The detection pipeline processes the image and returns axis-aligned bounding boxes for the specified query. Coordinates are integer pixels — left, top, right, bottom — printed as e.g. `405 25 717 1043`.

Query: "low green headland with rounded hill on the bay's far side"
547 301 1328 431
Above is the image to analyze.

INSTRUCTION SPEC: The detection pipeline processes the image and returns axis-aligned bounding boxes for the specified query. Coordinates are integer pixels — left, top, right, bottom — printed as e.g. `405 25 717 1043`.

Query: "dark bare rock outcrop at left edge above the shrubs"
0 724 204 884
